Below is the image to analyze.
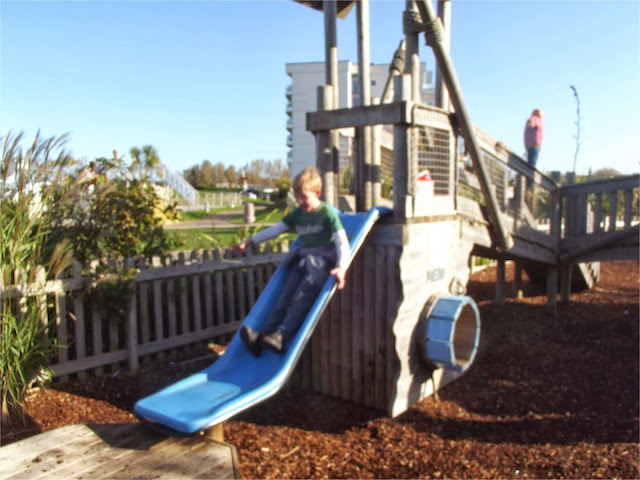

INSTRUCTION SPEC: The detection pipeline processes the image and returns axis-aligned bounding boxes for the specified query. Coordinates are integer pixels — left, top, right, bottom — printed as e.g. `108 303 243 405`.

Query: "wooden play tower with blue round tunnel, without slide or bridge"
301 0 488 416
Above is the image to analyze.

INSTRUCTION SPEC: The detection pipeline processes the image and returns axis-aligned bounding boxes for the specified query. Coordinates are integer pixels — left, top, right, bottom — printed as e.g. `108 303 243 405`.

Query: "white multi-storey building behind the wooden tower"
286 61 435 177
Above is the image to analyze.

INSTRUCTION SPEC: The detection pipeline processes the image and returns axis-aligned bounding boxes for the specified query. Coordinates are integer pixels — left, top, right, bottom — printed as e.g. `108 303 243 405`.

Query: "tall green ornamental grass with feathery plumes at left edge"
0 133 71 421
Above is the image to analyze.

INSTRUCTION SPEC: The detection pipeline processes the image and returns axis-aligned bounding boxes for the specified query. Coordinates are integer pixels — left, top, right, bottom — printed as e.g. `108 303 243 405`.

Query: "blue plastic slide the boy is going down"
134 207 391 435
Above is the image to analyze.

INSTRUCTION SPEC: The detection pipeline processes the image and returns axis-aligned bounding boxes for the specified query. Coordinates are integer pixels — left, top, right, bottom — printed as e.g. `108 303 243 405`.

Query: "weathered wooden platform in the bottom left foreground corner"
0 423 238 480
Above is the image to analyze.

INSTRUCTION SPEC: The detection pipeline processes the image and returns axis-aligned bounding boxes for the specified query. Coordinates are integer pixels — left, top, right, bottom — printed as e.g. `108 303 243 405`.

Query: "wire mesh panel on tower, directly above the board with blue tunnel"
415 127 451 195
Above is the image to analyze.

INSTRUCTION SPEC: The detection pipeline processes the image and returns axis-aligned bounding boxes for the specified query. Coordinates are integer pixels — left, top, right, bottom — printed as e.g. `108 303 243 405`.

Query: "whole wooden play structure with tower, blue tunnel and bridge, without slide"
292 0 638 416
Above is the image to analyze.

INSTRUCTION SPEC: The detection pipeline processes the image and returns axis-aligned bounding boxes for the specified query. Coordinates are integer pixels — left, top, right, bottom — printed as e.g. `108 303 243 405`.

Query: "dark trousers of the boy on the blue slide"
262 258 329 340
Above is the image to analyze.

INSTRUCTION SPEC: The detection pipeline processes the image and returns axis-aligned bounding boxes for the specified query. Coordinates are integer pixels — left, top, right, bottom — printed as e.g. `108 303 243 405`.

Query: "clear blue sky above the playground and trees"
0 0 640 174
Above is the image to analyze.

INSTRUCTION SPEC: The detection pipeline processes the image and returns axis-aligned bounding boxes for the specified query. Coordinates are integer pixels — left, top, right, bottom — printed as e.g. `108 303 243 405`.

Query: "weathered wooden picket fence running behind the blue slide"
0 244 287 380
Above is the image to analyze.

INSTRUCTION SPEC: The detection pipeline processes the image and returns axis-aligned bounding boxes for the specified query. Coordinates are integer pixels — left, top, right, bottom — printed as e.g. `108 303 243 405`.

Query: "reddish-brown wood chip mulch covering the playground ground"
1 261 640 479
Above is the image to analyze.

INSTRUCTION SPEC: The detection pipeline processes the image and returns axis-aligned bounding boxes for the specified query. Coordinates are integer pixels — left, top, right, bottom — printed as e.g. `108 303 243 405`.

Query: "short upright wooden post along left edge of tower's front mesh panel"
393 75 413 219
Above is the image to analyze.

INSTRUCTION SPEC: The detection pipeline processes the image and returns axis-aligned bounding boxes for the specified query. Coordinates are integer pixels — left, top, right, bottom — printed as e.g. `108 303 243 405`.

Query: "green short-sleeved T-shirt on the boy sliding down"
282 202 344 248
